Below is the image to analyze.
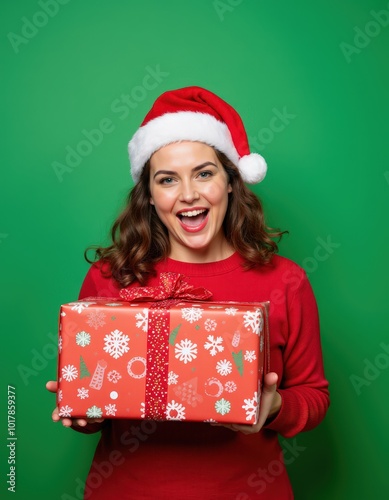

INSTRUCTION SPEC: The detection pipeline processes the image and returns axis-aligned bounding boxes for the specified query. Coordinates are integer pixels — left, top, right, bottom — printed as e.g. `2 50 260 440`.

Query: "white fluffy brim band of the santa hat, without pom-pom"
128 111 239 182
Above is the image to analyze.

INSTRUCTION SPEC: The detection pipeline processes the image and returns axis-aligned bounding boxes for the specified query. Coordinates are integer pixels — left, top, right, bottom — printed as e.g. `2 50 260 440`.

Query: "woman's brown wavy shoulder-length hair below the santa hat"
85 150 286 287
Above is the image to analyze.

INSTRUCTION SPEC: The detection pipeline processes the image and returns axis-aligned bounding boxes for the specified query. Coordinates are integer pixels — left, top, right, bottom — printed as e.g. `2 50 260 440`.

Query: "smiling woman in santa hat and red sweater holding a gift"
48 87 329 500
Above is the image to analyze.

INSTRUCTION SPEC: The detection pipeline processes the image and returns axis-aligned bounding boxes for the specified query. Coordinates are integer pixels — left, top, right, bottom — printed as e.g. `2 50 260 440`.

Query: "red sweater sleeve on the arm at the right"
265 273 329 438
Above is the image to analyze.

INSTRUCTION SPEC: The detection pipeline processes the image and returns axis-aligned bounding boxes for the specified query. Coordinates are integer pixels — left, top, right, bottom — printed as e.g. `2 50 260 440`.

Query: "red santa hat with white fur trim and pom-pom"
128 87 267 184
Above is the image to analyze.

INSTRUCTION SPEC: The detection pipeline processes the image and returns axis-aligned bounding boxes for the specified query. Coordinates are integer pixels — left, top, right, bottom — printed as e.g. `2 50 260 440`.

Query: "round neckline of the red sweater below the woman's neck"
160 252 243 276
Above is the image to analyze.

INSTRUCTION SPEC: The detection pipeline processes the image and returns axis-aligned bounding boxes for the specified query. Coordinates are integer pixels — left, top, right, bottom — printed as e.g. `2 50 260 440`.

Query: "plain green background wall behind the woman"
0 0 389 500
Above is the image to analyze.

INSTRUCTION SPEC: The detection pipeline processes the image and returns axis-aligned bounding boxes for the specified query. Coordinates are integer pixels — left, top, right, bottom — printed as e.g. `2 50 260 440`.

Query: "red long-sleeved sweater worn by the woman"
75 254 329 500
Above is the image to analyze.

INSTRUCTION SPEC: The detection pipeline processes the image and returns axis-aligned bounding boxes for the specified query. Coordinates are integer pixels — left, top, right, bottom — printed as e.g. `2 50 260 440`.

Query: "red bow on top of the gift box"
120 272 212 302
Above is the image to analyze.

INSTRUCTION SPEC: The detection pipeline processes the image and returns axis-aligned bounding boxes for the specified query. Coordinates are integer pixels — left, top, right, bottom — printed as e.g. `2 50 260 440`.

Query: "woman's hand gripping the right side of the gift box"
211 372 282 434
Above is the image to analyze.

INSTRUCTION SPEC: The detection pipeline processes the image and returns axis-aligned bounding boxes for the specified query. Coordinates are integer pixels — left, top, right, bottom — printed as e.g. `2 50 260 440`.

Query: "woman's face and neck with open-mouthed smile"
150 141 233 262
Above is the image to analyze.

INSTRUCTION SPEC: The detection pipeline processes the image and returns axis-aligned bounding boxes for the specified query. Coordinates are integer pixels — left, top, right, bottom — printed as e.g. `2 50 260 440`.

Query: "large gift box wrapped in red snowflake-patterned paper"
57 274 268 424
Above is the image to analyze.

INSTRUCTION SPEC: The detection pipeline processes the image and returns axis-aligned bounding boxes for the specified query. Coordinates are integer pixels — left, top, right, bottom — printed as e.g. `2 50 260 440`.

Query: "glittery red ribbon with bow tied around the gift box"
120 273 212 420
